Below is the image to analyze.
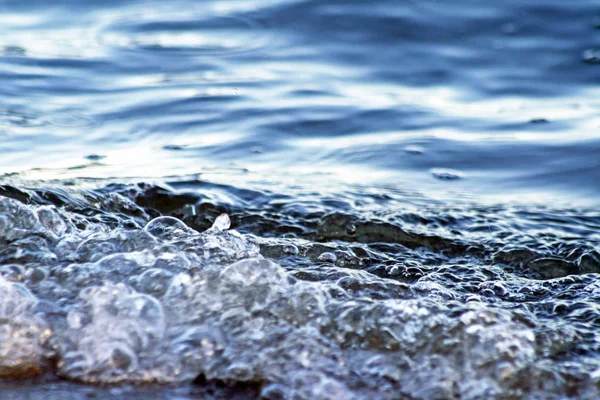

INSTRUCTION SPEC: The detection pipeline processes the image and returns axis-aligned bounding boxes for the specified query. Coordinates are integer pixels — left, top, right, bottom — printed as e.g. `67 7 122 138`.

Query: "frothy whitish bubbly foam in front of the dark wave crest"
0 195 597 400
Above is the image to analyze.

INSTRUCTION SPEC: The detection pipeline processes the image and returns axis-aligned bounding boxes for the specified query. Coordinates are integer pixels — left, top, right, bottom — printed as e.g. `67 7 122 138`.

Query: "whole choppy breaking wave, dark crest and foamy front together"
0 181 600 399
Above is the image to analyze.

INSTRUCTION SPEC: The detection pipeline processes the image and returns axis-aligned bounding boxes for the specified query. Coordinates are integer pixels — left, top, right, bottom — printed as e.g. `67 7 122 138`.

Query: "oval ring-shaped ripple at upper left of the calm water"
97 4 266 56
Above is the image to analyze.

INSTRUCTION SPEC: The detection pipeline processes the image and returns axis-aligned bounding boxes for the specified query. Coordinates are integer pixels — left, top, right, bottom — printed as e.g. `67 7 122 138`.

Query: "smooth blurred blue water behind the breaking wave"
0 0 600 201
